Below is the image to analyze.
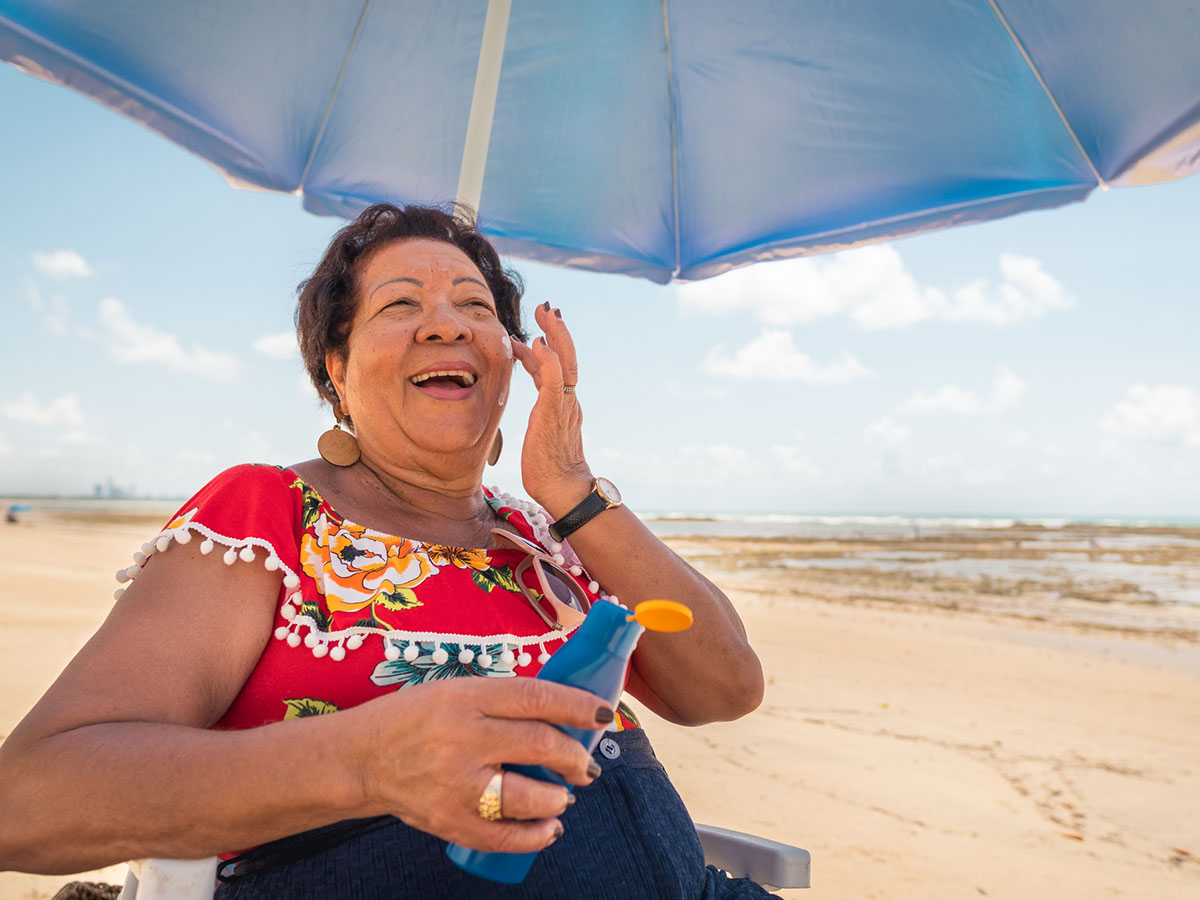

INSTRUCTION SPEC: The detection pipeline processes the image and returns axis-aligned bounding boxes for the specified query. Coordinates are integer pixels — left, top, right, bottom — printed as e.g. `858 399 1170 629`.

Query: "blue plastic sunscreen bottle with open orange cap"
446 600 691 884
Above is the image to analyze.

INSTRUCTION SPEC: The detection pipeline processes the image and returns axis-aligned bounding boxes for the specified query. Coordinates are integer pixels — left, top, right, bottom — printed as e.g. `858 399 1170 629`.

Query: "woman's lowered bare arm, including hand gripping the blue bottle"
0 535 599 874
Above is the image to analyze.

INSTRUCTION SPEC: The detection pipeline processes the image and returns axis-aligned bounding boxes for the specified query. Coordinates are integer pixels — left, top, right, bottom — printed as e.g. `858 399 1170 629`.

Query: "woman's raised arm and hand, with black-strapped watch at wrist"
514 307 763 725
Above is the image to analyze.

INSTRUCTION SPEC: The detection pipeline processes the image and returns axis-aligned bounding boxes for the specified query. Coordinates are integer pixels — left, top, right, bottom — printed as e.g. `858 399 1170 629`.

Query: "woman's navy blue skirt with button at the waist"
215 730 772 900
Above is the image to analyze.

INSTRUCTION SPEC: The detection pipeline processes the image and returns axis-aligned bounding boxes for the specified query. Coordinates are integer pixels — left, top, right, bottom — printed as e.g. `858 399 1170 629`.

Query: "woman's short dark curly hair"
296 203 526 404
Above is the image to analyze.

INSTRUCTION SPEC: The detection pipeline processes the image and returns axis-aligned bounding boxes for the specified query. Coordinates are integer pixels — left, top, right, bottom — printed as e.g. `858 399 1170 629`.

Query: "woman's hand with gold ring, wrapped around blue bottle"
337 678 613 853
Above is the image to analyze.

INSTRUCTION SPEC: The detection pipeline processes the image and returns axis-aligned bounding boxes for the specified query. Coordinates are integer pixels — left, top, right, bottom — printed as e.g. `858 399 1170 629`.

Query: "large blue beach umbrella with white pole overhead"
0 0 1200 282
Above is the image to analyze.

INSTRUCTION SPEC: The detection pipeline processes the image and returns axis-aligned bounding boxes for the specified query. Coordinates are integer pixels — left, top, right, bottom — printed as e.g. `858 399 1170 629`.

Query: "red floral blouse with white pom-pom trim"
118 464 638 730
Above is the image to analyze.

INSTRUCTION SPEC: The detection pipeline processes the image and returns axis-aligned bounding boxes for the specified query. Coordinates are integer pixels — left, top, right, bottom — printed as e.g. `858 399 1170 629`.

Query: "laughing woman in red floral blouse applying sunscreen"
0 204 762 898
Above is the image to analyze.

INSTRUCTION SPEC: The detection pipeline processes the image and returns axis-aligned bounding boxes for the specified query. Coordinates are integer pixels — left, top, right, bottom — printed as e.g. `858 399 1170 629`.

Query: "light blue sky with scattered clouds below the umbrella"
0 65 1200 520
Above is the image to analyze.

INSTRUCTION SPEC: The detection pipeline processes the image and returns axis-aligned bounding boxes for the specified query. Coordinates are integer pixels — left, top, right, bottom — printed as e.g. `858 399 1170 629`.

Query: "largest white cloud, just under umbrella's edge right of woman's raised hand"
676 245 1075 330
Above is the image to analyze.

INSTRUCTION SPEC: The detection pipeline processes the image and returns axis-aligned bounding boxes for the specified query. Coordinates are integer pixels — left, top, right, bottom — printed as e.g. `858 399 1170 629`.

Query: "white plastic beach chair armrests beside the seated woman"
118 824 811 900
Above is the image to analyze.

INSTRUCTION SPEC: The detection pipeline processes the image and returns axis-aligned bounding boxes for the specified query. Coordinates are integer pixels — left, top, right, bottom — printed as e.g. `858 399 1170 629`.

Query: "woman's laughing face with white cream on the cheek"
325 239 512 468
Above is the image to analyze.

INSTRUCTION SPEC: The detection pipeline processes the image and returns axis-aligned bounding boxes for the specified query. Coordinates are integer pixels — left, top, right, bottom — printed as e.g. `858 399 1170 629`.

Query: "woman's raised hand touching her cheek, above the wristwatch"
512 304 592 510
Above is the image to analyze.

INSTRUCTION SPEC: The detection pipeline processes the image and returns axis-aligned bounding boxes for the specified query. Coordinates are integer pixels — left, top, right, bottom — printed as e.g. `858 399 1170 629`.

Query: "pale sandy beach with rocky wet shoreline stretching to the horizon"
0 511 1200 900
